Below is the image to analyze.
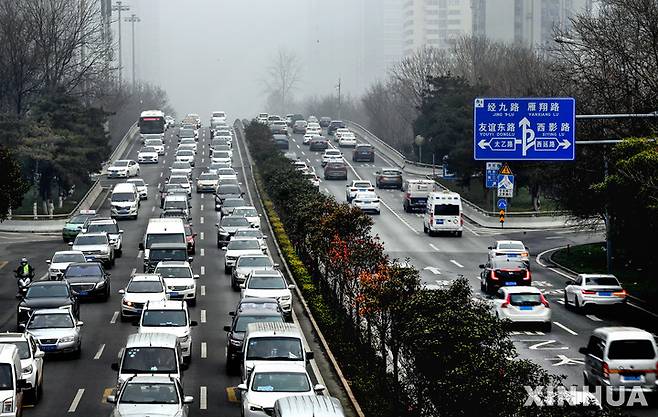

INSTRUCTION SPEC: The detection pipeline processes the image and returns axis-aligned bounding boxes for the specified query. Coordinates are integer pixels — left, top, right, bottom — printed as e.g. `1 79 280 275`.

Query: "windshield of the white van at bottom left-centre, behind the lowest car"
121 347 178 374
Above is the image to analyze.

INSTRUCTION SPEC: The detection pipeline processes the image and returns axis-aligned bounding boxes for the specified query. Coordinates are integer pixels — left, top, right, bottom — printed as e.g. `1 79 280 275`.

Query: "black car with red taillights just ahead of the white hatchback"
480 257 532 294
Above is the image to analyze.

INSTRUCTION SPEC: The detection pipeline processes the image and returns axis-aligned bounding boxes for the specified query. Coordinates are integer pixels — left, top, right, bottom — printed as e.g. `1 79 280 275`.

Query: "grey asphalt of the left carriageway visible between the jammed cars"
0 122 345 417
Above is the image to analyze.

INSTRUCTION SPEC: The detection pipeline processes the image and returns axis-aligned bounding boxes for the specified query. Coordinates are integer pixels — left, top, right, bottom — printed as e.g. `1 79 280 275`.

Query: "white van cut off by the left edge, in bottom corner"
0 344 31 417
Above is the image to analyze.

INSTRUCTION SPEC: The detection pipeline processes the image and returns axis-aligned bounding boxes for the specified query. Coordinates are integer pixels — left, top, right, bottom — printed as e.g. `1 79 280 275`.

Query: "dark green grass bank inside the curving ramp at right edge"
552 242 658 307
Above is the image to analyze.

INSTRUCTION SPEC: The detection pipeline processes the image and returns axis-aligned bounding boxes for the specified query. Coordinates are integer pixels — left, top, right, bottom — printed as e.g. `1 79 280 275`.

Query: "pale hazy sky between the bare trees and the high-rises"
113 0 372 119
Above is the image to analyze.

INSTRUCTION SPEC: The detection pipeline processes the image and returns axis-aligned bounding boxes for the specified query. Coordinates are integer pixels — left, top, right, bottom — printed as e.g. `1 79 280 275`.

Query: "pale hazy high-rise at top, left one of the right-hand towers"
402 0 473 55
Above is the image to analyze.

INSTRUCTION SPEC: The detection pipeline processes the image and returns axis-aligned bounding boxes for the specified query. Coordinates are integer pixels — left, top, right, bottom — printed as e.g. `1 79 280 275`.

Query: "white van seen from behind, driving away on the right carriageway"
423 191 464 237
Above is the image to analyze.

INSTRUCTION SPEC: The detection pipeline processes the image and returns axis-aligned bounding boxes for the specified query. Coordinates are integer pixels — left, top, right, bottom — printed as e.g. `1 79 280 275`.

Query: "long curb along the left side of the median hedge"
232 121 365 417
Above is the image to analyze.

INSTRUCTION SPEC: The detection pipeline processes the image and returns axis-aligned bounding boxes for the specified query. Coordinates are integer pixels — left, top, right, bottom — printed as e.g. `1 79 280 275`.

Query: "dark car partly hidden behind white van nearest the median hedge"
224 308 284 372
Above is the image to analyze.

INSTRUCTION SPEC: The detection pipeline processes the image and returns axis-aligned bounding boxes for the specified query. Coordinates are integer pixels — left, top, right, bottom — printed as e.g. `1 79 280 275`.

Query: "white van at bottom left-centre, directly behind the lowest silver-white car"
112 333 183 387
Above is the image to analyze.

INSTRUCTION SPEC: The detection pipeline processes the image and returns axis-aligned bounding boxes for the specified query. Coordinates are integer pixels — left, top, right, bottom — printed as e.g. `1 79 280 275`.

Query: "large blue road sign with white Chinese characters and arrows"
473 98 576 161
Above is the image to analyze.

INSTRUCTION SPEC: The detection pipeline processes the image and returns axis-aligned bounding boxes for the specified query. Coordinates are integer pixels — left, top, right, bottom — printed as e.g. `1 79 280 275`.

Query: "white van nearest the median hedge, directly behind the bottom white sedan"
242 322 313 381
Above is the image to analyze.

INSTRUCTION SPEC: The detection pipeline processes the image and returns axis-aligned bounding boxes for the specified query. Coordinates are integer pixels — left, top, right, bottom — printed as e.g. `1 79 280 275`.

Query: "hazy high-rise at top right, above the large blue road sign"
472 0 593 48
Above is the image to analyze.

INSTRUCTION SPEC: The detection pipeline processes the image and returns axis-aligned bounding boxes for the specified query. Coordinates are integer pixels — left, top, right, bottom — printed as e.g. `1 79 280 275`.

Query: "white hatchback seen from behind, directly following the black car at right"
494 286 551 332
